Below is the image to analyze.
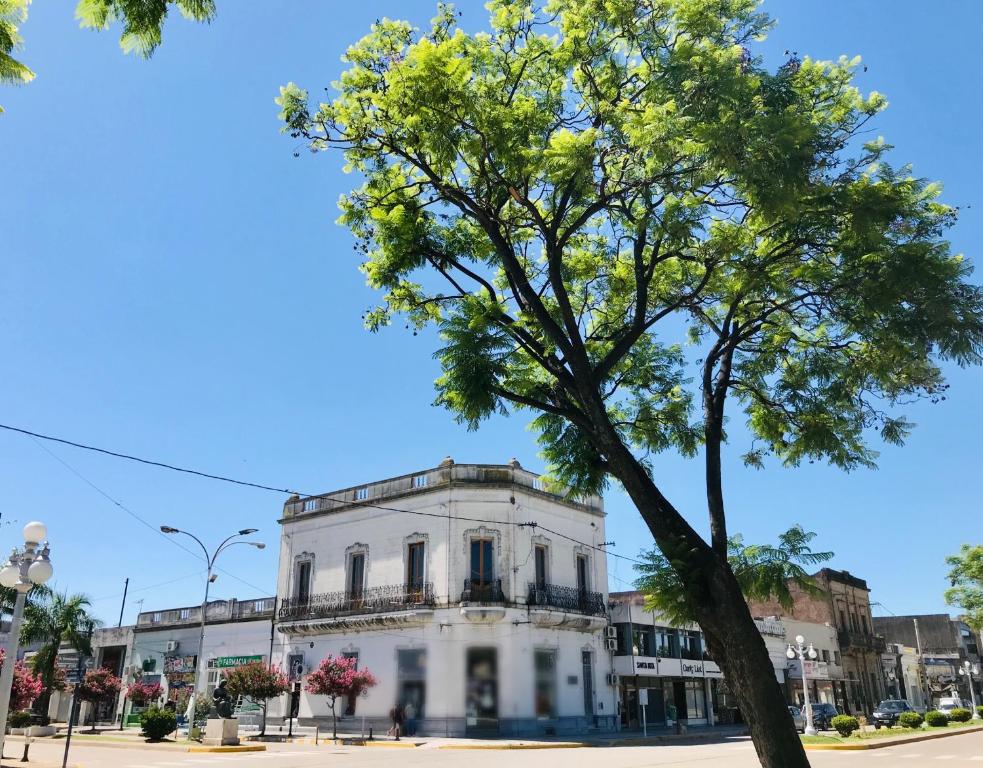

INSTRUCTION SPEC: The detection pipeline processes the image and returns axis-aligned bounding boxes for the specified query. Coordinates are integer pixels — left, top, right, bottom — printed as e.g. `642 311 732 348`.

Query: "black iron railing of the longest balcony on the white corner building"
277 581 436 621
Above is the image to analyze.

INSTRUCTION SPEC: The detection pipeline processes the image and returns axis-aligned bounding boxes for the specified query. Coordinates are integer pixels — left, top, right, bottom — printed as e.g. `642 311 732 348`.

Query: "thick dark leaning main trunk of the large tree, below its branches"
603 434 809 768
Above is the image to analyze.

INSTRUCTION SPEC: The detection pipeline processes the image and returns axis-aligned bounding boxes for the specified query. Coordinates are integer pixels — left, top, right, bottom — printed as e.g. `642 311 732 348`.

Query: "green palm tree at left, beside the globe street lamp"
21 592 100 715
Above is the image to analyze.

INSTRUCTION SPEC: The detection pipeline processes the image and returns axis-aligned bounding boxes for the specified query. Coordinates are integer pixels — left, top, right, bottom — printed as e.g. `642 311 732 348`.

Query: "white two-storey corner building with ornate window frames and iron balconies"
271 458 617 736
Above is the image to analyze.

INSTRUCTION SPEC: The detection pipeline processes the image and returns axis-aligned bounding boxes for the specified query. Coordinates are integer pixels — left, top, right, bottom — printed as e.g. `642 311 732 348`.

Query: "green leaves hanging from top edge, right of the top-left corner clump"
75 0 215 58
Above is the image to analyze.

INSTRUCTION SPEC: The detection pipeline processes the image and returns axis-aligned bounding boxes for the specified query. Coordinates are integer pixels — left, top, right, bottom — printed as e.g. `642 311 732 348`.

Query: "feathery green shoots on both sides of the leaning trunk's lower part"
635 525 833 622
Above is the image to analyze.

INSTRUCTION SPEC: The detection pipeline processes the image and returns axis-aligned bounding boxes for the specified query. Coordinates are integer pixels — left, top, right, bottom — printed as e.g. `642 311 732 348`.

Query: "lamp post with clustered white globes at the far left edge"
0 522 52 756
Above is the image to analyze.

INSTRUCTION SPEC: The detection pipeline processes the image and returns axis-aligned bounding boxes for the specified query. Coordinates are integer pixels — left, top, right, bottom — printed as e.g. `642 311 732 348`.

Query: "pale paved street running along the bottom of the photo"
5 733 983 768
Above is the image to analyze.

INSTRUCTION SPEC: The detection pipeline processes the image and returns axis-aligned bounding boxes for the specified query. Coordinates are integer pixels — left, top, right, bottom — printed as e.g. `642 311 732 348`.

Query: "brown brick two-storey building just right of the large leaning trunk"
750 568 885 714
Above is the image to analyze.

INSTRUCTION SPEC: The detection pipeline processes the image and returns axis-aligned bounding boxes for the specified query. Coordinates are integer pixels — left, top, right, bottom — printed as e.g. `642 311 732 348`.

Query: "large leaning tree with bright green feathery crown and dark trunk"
277 0 983 768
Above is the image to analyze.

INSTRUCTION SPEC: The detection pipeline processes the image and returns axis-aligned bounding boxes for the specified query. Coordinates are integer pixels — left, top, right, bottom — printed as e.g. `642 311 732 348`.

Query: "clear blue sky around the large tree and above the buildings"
0 0 983 623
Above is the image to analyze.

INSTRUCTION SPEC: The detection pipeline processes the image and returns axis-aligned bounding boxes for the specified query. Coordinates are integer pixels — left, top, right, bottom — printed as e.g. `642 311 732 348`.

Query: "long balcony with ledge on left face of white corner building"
277 582 436 635
